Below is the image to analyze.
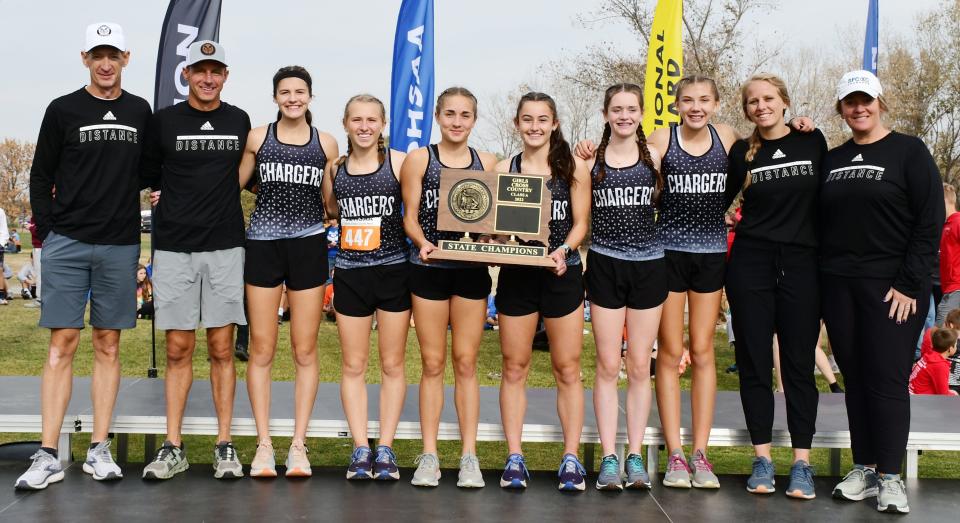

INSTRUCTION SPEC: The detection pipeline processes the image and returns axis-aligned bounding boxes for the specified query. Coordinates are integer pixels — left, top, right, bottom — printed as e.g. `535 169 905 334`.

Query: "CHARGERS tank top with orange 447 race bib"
333 151 406 269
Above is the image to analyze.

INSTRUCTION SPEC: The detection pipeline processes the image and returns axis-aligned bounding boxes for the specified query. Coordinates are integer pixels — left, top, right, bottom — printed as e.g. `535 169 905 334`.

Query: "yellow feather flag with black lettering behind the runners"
643 0 683 136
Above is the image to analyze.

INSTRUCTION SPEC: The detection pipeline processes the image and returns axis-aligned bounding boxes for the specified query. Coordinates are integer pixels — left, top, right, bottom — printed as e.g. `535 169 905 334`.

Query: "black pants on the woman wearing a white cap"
816 275 930 474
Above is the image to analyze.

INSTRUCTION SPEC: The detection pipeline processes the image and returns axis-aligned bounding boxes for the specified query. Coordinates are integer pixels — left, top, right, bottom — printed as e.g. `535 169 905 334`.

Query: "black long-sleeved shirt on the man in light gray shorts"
144 102 250 252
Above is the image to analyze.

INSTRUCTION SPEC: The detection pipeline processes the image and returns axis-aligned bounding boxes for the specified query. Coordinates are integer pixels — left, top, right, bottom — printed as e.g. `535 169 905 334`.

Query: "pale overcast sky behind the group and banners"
0 0 941 144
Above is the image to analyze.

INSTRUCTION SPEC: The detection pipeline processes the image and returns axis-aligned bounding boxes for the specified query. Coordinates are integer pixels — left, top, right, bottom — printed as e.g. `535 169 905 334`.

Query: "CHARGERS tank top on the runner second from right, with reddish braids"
590 155 663 261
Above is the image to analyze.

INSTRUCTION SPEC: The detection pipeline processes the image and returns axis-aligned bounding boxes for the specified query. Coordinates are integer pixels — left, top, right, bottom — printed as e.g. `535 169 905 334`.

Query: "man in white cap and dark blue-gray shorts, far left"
15 23 150 489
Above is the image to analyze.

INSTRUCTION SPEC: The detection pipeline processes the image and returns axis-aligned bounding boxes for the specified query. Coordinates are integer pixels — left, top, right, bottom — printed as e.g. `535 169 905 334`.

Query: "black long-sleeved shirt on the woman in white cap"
820 132 946 299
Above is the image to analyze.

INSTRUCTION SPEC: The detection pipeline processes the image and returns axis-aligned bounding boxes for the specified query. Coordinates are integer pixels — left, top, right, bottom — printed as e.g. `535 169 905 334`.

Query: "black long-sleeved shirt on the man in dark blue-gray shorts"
30 88 150 245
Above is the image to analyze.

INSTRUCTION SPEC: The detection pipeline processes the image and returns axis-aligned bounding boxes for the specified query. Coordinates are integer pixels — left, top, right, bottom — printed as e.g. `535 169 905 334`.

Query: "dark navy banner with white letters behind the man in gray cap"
153 0 221 111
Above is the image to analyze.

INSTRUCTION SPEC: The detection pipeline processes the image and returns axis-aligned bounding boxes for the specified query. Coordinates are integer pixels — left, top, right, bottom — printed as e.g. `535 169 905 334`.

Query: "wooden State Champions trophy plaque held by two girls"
430 169 556 267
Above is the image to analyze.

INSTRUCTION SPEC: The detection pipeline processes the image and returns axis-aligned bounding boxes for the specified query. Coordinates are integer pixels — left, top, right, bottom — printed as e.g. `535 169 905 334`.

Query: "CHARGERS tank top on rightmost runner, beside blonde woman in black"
657 124 728 252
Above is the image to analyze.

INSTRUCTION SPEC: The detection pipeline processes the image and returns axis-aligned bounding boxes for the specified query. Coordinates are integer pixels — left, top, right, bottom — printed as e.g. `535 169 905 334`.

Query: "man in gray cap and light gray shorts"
143 40 250 479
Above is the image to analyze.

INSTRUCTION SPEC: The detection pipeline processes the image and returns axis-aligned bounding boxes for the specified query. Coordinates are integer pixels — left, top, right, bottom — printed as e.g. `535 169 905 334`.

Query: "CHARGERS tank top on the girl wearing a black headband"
247 123 327 240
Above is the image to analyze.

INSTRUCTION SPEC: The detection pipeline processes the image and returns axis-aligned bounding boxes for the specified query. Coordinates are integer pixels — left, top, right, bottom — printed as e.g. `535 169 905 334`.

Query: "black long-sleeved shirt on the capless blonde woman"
726 129 827 247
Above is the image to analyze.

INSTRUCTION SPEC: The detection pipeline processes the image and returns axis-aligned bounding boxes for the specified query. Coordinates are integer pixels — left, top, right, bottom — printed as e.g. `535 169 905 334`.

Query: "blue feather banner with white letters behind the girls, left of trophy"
390 0 433 152
